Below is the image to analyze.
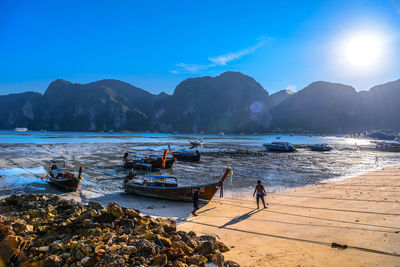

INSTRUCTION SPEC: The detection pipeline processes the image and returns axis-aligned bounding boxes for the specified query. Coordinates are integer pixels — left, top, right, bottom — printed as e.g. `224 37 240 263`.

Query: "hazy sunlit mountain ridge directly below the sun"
271 80 400 133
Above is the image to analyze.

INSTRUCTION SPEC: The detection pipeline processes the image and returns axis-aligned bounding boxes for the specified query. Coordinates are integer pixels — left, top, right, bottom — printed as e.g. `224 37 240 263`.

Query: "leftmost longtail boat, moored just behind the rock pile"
46 160 83 191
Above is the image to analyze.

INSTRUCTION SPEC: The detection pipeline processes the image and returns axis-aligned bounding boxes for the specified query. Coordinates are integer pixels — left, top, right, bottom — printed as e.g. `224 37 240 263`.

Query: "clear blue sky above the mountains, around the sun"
0 0 400 94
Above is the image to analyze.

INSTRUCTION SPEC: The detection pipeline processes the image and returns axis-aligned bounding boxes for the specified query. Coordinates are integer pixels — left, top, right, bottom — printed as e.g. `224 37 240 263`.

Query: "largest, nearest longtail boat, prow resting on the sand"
124 168 231 202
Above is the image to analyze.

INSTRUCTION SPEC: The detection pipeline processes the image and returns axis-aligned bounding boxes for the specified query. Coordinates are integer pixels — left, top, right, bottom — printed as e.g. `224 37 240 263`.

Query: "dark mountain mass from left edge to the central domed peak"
0 79 157 131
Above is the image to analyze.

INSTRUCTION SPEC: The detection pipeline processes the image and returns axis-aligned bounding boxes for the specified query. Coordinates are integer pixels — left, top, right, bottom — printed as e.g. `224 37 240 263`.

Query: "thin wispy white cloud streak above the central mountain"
170 37 271 74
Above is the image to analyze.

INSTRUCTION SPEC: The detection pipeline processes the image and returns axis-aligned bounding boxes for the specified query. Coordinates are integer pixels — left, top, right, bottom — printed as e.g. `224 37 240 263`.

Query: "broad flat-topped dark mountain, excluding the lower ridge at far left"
43 80 156 131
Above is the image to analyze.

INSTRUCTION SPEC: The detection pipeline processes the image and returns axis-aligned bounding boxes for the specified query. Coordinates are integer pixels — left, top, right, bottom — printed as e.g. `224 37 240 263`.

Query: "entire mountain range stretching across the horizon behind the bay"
0 71 400 134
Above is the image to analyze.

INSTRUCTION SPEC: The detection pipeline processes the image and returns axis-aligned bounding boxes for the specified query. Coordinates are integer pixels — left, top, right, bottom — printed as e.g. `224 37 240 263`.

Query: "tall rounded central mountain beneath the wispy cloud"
154 71 272 133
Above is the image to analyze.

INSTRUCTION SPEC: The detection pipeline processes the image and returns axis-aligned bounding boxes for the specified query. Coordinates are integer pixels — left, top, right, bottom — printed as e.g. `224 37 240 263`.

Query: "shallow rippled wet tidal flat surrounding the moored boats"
0 139 400 194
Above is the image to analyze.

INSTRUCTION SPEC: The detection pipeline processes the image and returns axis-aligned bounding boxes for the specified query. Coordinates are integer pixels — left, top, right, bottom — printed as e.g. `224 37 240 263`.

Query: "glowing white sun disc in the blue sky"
340 33 384 70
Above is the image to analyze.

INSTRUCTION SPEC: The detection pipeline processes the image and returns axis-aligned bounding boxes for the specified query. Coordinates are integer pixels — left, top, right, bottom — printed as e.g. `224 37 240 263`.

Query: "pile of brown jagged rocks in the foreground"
0 194 239 266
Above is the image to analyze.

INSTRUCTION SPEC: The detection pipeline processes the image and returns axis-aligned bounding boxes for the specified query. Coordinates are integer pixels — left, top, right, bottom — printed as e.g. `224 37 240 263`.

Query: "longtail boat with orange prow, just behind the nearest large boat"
122 149 176 171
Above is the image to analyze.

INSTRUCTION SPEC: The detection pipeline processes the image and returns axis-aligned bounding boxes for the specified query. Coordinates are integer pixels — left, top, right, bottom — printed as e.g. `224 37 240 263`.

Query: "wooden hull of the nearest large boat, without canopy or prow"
124 182 221 202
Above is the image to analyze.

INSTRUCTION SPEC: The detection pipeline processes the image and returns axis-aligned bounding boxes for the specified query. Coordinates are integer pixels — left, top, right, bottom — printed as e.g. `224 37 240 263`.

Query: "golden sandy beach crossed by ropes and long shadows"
178 166 400 266
